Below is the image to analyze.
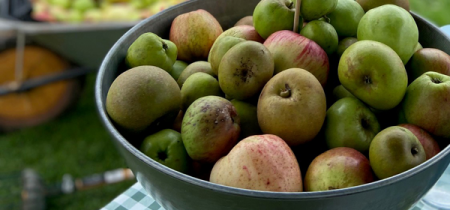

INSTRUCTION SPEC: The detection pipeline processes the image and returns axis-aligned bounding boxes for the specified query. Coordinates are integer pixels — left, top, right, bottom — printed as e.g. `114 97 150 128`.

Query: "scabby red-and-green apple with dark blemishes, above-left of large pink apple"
181 96 240 163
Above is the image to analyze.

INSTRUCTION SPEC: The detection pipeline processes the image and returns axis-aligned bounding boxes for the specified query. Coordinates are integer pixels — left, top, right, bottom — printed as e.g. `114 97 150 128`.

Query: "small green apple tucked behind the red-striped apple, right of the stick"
300 20 339 55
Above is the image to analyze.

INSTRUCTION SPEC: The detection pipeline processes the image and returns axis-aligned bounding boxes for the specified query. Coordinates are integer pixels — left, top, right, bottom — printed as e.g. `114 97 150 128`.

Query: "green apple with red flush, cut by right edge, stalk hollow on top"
402 72 450 138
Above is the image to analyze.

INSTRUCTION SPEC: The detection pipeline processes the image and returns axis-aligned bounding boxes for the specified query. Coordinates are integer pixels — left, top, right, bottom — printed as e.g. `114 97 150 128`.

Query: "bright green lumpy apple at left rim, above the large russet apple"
125 32 177 72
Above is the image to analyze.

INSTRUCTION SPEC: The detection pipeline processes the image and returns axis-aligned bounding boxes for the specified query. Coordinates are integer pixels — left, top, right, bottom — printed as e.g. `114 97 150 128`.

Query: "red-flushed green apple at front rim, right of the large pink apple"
304 147 374 191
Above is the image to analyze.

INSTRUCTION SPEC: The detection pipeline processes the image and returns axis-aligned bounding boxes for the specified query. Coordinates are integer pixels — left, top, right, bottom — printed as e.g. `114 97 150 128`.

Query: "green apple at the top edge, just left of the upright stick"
253 0 303 39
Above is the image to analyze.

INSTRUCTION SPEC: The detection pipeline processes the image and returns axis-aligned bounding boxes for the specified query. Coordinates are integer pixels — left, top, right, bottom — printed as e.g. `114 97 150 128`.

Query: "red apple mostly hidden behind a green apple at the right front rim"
399 124 441 160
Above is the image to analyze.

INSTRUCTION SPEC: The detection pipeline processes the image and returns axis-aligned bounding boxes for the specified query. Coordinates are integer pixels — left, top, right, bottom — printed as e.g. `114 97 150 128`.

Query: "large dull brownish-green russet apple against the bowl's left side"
106 66 181 132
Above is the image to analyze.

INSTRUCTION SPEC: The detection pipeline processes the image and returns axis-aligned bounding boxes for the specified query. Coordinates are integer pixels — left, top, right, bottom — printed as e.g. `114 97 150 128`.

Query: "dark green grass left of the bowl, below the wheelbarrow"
0 74 135 210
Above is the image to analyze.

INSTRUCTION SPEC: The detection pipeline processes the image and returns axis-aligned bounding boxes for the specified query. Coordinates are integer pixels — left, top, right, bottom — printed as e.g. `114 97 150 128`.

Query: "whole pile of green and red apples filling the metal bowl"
106 0 450 192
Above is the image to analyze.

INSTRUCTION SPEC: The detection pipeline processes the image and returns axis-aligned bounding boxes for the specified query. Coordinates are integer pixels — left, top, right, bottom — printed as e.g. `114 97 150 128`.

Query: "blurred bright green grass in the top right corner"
409 0 450 26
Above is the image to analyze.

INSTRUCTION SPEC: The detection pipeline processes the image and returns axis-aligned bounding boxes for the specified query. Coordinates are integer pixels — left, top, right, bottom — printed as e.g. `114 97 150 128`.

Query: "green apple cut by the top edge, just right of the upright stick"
300 0 338 21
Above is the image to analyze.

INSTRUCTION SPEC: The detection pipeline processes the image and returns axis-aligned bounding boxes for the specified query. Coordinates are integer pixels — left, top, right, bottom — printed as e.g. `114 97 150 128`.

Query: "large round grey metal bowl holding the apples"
95 0 450 210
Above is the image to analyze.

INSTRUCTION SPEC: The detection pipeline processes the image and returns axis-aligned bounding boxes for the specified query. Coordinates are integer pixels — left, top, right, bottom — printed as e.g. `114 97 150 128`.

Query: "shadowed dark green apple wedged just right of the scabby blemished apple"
231 99 262 139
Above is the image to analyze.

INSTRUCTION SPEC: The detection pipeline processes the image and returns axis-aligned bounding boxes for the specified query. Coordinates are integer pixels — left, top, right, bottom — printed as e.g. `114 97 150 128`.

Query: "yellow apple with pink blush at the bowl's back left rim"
170 9 223 62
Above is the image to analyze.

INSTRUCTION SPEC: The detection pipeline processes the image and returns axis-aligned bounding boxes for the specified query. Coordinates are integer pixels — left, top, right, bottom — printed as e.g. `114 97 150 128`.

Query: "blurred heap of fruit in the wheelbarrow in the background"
32 0 185 23
